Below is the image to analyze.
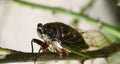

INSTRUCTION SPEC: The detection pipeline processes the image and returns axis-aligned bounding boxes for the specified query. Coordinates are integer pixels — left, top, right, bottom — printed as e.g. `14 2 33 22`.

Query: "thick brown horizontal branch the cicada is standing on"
0 43 120 63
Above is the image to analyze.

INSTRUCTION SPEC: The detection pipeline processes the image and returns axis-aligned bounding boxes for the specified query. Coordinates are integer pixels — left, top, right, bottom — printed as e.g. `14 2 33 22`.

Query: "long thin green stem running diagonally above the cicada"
12 0 120 38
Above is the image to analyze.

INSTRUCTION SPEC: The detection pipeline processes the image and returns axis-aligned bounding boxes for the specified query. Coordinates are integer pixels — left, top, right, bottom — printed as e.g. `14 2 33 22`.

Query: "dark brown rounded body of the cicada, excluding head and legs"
44 22 88 51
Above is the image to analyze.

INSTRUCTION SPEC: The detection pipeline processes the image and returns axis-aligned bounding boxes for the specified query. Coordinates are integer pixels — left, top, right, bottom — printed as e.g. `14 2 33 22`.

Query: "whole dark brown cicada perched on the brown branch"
31 22 110 61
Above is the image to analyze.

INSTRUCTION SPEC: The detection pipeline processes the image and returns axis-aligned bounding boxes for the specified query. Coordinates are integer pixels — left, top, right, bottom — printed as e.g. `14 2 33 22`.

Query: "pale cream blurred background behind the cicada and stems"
0 0 120 64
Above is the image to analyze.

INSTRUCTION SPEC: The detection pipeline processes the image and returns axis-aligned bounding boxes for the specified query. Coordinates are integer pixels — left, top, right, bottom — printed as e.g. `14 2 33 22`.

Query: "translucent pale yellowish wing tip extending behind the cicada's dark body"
79 30 111 50
